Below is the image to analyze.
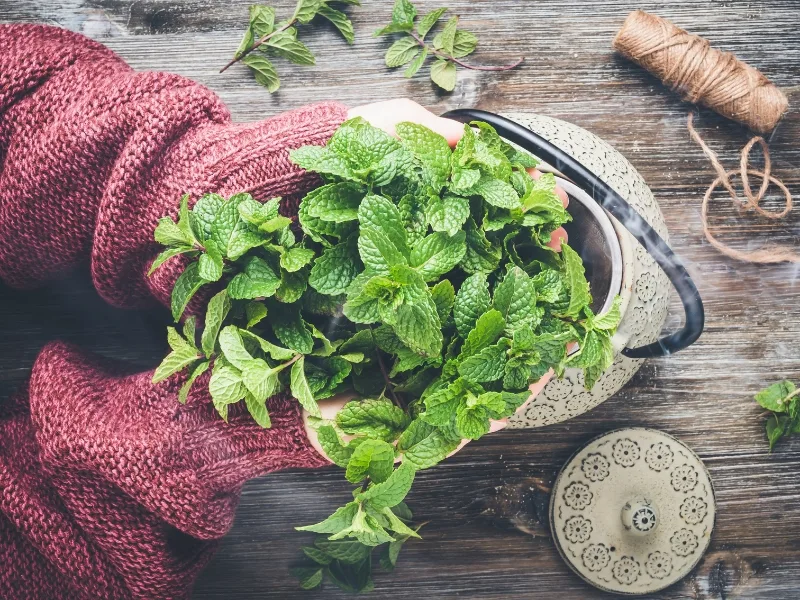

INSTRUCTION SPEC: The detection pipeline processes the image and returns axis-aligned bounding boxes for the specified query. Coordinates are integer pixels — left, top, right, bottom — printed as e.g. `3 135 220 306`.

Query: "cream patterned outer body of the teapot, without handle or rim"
503 113 671 429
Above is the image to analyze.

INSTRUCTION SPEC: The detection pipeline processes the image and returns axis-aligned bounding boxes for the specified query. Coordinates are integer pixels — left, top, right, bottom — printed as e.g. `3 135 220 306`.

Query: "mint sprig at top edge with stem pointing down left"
220 0 359 93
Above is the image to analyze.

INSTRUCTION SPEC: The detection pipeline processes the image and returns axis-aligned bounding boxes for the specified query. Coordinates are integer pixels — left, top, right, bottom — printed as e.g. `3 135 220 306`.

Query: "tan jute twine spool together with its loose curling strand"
614 10 800 263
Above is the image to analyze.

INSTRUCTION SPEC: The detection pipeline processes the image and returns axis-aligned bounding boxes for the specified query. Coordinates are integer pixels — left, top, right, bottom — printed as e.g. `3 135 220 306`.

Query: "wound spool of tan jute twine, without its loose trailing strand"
614 10 789 133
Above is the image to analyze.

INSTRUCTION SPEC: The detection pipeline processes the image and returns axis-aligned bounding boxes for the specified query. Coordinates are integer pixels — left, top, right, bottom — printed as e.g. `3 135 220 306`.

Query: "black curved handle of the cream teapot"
442 108 705 358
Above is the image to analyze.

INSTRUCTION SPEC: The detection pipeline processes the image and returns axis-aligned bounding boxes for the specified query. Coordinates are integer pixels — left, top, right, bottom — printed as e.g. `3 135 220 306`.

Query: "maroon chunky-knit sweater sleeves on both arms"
0 25 346 599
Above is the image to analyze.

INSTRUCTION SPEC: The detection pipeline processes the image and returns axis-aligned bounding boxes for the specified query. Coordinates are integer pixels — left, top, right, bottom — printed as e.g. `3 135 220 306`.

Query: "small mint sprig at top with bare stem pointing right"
374 0 525 92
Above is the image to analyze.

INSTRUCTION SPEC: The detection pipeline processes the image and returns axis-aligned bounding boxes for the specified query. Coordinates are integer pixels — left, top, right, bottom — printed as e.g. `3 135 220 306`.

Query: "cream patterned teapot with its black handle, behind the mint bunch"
443 109 704 428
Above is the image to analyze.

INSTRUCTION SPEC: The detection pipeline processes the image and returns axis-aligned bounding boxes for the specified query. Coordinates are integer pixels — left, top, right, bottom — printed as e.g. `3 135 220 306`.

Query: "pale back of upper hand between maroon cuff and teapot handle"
347 98 464 146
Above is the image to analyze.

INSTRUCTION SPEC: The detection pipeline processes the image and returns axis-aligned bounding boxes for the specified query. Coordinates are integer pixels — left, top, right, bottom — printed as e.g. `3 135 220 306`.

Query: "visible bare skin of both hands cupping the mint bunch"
303 98 569 458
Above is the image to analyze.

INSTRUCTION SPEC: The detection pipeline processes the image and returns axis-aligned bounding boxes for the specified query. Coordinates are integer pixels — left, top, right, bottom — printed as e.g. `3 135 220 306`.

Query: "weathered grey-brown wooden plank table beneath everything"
0 0 800 600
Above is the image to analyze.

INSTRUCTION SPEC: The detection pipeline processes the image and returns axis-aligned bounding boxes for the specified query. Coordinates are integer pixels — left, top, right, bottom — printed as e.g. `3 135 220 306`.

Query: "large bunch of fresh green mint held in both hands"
153 119 620 591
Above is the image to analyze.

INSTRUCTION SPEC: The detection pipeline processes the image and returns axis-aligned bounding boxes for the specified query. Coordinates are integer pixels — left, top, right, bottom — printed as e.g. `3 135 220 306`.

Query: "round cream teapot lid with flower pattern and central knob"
550 428 716 594
